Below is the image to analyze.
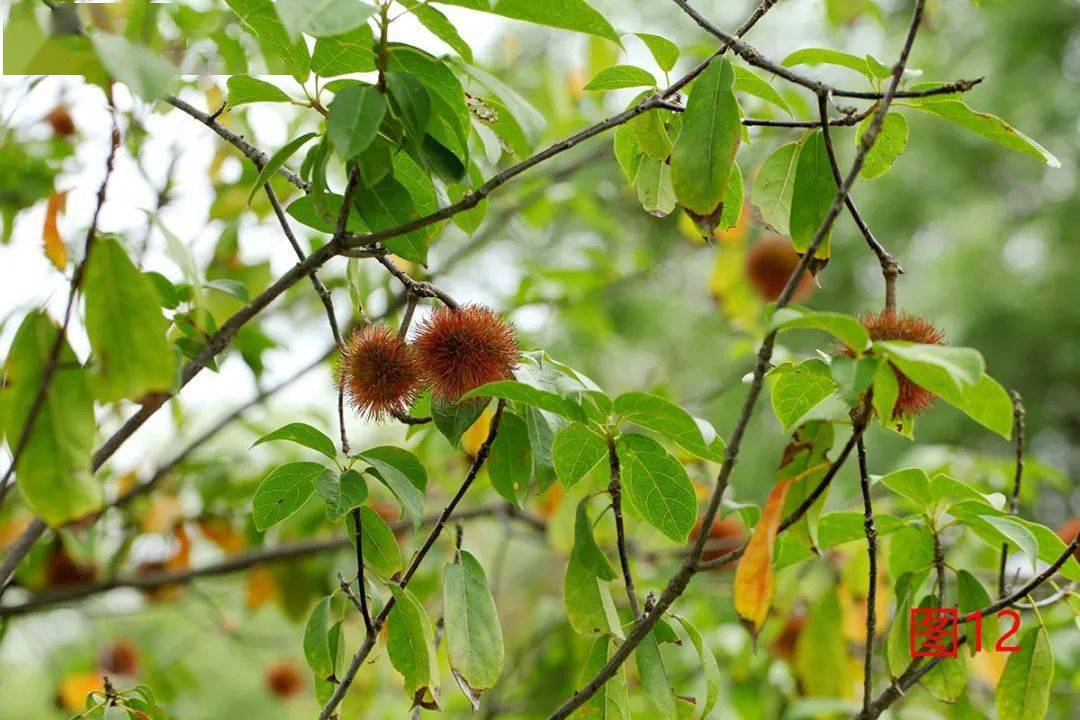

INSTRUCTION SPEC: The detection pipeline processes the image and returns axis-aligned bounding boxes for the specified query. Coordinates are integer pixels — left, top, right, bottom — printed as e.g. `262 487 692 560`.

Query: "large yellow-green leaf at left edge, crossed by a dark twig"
0 310 104 527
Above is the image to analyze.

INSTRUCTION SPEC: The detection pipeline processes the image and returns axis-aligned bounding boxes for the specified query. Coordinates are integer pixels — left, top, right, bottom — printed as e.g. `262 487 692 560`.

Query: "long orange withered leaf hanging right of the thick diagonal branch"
735 479 792 635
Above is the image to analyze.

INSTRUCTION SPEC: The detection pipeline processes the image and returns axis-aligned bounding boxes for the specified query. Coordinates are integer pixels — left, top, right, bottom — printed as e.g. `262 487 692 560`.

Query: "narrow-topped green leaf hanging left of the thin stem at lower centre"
563 499 619 635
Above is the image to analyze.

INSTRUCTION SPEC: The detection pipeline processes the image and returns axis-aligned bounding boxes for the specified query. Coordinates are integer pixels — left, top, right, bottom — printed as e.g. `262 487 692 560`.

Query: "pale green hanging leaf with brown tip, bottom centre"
443 551 504 711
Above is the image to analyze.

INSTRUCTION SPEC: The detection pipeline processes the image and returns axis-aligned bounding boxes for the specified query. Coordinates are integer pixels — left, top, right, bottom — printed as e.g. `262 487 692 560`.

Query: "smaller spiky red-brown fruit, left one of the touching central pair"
338 325 420 420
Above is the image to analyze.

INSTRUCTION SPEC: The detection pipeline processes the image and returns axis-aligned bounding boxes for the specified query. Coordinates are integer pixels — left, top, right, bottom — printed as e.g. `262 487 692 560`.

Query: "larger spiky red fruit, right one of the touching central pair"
415 305 517 400
